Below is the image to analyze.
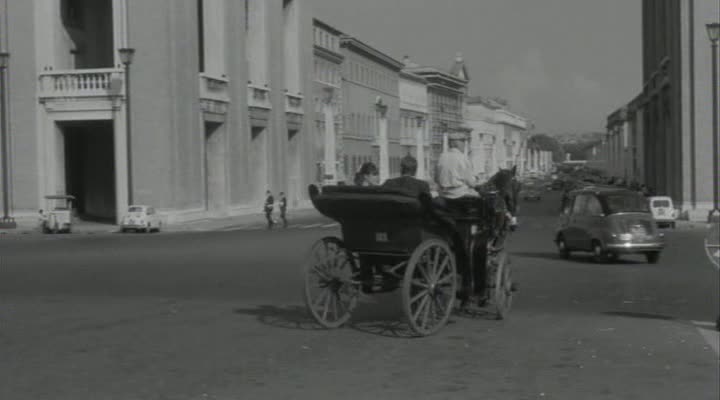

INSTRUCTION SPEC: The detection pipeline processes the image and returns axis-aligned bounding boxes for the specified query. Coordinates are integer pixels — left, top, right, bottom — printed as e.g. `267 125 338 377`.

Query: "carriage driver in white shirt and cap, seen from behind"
435 132 478 199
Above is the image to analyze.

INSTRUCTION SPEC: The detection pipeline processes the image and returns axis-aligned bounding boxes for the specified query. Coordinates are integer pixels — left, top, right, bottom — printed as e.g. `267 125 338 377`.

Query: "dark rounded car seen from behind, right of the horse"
555 187 664 264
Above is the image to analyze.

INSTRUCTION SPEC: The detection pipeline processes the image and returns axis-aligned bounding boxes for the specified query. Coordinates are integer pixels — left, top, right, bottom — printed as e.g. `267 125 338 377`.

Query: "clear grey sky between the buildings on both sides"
305 0 642 133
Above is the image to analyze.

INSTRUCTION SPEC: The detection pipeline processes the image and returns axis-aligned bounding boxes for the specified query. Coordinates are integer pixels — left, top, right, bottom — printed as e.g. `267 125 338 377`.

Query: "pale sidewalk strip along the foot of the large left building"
0 208 327 236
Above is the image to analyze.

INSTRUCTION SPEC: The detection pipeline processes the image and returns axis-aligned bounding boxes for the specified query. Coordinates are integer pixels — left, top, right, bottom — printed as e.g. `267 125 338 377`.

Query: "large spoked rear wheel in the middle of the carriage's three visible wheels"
402 239 457 336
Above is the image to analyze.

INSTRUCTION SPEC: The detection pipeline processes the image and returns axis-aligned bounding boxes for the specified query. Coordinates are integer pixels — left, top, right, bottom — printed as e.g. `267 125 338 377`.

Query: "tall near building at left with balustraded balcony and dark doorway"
0 0 315 222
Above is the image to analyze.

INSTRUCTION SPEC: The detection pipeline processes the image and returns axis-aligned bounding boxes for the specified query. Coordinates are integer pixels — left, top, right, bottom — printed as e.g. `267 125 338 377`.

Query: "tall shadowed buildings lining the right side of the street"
591 0 720 220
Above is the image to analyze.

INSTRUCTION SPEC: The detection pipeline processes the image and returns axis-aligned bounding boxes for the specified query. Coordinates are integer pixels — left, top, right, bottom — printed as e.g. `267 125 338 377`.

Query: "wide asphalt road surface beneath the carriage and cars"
0 192 720 400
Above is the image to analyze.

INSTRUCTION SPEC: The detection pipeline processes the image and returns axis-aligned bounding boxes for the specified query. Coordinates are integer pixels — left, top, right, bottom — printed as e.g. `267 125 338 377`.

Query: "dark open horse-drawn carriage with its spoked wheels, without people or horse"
305 185 513 335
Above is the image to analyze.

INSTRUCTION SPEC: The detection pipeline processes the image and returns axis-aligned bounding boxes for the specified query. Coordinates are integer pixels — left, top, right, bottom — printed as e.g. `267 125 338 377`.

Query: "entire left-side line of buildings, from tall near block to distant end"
0 0 550 223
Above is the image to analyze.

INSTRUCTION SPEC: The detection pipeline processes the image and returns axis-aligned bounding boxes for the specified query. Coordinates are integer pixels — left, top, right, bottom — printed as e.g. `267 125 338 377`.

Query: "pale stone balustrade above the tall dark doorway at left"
39 68 125 98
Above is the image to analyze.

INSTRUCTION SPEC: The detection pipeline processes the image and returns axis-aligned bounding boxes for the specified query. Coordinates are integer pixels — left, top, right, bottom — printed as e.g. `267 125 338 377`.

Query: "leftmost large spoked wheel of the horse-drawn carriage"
305 237 360 328
